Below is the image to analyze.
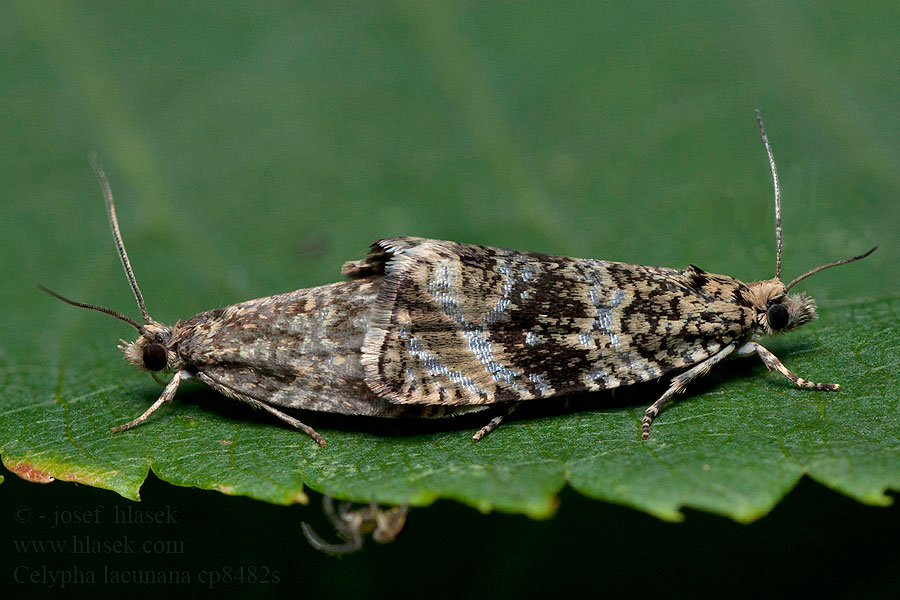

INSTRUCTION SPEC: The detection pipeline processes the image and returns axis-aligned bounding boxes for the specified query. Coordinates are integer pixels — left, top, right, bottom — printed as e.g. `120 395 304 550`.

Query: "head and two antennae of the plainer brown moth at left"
39 154 179 373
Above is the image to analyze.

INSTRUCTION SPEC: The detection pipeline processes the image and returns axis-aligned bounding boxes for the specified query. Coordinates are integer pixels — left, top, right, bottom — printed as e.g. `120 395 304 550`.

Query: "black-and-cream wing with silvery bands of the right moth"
356 238 754 406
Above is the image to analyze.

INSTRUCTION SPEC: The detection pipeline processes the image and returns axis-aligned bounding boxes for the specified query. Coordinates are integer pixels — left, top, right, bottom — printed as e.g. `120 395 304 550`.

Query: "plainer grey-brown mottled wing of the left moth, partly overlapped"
176 277 400 415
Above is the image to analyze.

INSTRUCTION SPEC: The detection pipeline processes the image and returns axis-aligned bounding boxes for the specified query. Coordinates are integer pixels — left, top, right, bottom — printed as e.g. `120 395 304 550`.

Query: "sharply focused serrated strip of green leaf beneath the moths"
0 298 900 521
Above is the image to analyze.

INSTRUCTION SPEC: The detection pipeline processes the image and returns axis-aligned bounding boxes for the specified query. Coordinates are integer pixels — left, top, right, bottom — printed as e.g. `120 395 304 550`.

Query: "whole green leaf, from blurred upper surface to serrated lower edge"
0 2 900 520
